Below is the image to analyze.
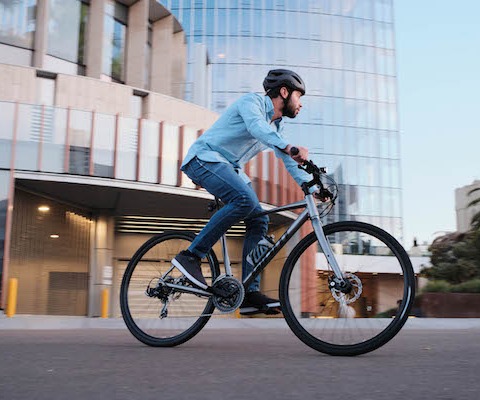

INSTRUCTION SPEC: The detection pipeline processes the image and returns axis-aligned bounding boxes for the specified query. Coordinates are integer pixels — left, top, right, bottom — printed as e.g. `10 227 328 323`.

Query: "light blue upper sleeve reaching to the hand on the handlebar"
238 96 288 149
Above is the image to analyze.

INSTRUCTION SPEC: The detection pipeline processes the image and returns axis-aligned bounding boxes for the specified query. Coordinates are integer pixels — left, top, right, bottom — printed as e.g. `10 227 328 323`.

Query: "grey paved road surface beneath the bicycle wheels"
0 328 480 400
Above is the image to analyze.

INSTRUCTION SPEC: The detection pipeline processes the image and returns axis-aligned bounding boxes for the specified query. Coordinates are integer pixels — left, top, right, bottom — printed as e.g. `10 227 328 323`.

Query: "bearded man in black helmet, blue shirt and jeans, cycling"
172 69 316 315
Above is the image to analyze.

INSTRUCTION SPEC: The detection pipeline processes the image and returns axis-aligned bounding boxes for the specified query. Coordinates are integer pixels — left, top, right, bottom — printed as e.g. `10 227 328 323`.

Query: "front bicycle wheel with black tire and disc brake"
279 221 415 356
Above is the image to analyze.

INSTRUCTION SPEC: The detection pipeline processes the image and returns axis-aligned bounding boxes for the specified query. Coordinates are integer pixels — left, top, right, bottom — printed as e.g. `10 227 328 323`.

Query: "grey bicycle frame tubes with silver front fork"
161 194 344 296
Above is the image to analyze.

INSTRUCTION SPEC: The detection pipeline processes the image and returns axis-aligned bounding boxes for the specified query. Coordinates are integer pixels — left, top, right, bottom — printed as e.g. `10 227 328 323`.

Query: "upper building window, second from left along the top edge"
48 0 88 65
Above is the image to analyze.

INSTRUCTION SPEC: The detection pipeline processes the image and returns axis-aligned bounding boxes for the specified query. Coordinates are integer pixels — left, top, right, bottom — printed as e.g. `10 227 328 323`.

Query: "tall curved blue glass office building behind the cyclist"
160 0 402 239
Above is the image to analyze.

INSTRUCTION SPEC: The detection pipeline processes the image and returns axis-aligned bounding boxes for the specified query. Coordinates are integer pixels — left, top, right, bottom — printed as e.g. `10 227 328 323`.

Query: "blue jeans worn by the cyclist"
183 157 268 292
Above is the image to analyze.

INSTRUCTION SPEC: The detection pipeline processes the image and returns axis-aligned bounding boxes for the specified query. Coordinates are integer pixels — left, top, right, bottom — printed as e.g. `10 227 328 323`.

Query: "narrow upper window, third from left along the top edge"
103 2 128 83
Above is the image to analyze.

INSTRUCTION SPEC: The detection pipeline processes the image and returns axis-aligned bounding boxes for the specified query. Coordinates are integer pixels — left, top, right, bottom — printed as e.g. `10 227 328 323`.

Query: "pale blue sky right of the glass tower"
394 0 480 248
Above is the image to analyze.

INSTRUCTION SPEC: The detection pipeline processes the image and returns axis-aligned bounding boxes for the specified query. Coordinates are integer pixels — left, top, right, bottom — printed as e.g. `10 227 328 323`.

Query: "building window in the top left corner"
0 0 37 49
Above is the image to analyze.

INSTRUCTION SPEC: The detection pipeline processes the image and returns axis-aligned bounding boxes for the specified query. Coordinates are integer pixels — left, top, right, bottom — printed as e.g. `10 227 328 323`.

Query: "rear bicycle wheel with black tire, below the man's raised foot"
120 231 220 347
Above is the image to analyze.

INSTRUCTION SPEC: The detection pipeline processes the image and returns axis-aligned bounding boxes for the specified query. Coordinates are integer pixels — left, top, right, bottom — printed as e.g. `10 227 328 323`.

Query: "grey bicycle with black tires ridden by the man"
120 156 415 356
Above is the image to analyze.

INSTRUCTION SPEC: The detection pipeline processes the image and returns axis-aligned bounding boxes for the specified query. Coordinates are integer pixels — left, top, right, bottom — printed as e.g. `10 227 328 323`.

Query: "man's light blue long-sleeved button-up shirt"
182 93 311 189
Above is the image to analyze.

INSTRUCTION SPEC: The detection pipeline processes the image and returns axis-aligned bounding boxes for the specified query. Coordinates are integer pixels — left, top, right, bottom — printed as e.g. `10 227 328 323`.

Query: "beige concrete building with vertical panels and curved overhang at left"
0 0 304 316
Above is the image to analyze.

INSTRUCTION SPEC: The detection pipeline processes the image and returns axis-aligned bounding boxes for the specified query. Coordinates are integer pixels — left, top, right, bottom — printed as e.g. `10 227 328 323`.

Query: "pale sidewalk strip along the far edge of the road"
0 313 480 331
